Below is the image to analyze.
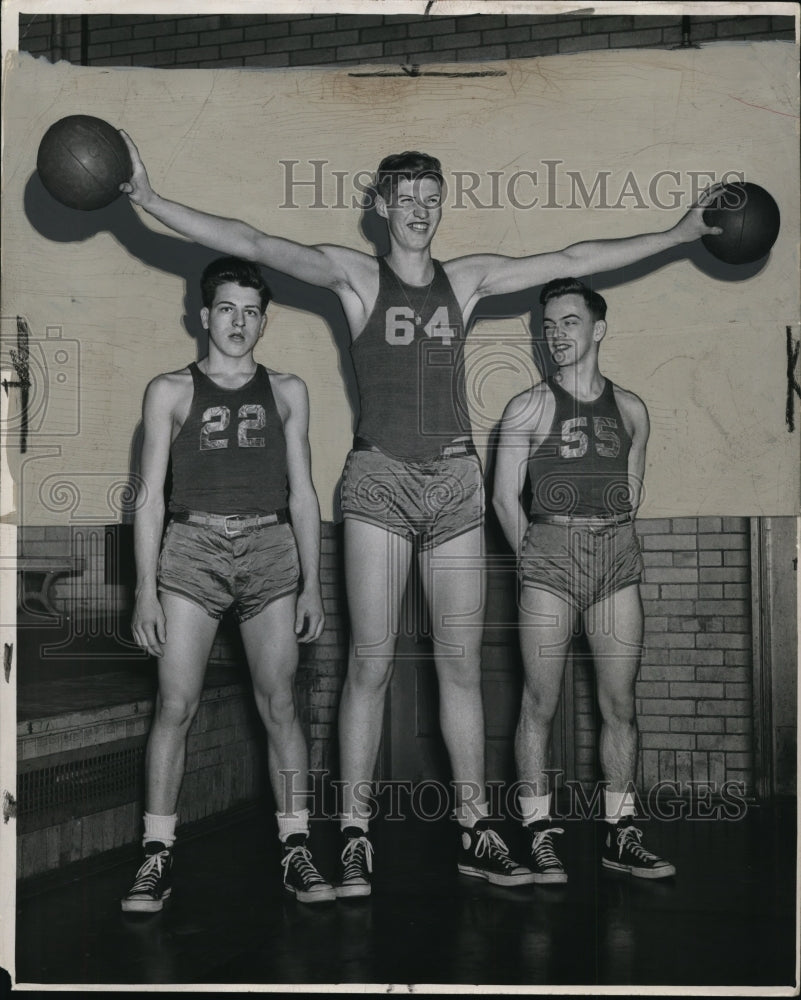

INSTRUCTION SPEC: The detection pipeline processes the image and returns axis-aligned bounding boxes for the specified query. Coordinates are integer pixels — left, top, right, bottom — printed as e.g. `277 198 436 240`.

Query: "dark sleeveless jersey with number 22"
169 362 288 514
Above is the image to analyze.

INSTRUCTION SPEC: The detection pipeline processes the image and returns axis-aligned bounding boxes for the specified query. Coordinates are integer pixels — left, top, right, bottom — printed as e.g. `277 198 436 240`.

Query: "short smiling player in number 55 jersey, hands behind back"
494 278 676 883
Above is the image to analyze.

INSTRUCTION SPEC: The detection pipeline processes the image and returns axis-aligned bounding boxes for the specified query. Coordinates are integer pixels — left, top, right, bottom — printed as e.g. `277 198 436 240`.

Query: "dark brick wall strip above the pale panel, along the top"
19 14 794 68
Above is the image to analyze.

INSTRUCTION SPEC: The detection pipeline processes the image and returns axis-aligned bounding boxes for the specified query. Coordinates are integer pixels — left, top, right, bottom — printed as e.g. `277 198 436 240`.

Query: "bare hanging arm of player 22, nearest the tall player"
273 375 325 642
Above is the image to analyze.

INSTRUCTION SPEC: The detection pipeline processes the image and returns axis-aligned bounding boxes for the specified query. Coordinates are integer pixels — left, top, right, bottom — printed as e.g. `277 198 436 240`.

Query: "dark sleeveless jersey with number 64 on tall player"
351 257 470 461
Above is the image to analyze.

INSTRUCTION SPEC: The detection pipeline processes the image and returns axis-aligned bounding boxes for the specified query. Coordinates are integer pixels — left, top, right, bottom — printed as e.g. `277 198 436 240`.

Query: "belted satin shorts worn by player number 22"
158 521 300 622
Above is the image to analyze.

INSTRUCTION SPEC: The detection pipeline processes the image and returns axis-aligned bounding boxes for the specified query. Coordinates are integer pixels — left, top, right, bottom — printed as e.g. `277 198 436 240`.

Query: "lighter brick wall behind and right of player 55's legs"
574 517 754 795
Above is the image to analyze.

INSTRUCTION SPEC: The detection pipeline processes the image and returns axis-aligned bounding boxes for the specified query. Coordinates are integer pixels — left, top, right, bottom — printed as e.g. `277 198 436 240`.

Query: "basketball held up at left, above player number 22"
36 115 131 211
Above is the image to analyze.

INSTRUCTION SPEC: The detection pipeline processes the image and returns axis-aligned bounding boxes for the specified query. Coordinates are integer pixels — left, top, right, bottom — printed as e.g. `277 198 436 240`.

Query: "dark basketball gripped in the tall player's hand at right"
701 182 779 264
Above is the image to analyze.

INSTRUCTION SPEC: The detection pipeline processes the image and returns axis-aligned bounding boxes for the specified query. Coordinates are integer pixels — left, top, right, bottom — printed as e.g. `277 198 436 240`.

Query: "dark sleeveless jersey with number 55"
528 378 631 518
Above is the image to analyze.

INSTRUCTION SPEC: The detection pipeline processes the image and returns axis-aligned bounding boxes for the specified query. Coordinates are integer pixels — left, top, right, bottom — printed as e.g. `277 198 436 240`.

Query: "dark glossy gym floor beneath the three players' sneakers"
16 802 798 987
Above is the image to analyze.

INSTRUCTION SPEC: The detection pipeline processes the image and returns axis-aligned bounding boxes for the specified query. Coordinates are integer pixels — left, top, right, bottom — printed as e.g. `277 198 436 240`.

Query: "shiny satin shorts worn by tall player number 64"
342 451 484 550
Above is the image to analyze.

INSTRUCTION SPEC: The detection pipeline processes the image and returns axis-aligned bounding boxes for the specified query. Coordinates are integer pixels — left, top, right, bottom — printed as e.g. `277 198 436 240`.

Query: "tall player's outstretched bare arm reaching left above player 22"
120 131 357 289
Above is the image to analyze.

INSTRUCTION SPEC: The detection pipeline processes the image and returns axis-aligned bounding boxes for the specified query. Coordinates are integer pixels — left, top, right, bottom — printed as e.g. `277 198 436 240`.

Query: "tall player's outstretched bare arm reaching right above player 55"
455 185 721 298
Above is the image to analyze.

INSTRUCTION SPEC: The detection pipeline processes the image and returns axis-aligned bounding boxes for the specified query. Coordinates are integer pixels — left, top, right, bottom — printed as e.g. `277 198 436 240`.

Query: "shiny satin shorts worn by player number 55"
519 521 643 611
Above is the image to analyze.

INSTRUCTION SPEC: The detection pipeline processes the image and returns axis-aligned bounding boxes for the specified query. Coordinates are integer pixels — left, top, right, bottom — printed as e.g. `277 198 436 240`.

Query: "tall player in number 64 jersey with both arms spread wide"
120 133 718 896
